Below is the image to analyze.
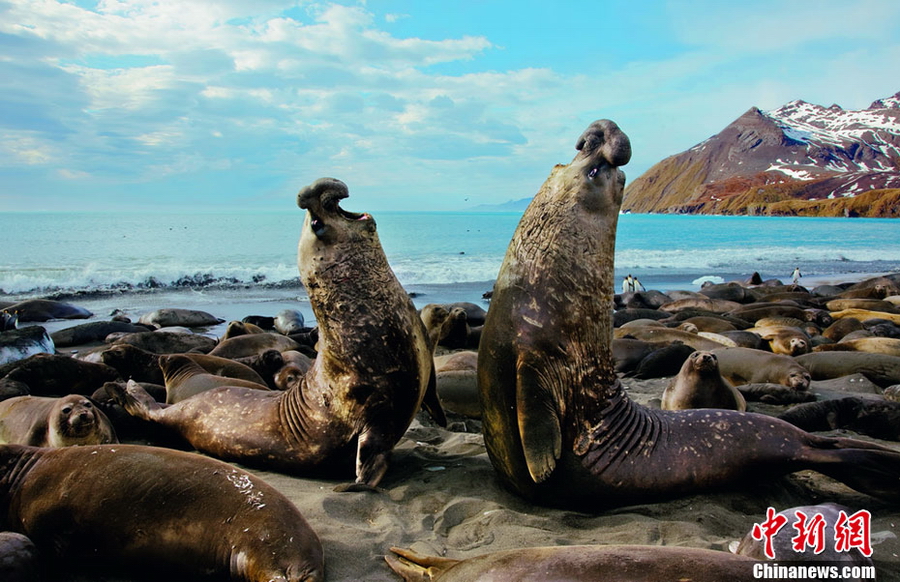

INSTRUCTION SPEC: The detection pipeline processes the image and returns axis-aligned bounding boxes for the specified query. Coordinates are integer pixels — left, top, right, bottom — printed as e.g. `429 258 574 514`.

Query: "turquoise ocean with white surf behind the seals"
0 211 900 336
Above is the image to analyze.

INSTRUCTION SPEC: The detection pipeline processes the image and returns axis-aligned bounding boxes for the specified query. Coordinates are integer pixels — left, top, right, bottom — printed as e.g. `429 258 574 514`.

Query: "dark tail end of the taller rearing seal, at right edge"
810 438 900 503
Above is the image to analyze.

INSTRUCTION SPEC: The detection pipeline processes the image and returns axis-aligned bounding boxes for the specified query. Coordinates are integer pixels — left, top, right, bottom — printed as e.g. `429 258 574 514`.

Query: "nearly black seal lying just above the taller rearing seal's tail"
778 396 900 441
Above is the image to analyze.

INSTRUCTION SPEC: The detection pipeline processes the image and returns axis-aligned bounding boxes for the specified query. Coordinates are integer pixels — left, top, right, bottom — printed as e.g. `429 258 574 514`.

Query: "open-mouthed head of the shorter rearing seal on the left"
297 178 375 244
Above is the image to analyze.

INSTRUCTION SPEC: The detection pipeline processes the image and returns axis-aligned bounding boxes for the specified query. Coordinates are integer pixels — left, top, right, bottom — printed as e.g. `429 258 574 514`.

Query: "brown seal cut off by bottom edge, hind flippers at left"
385 545 758 582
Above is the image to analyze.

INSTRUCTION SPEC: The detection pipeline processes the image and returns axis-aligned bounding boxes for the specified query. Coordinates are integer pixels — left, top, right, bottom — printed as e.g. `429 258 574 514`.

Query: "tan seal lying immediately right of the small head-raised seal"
713 347 812 390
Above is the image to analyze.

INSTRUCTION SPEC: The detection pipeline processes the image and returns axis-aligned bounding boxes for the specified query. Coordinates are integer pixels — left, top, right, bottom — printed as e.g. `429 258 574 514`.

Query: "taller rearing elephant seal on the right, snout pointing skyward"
478 121 900 511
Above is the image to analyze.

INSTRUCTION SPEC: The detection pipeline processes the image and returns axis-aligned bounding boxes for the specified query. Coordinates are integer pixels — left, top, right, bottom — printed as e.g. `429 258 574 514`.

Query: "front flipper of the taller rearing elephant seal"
516 355 562 483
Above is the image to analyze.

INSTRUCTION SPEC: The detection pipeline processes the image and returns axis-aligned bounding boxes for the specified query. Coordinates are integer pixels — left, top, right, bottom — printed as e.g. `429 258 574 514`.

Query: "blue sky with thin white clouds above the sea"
0 0 900 211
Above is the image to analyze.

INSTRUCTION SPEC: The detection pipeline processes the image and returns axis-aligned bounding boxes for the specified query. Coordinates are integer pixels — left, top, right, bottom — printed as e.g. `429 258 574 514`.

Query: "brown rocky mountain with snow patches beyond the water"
622 93 900 217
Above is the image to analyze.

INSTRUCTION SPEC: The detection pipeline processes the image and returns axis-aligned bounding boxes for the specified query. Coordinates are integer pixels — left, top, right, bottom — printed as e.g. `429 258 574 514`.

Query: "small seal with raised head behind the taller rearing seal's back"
662 352 747 411
